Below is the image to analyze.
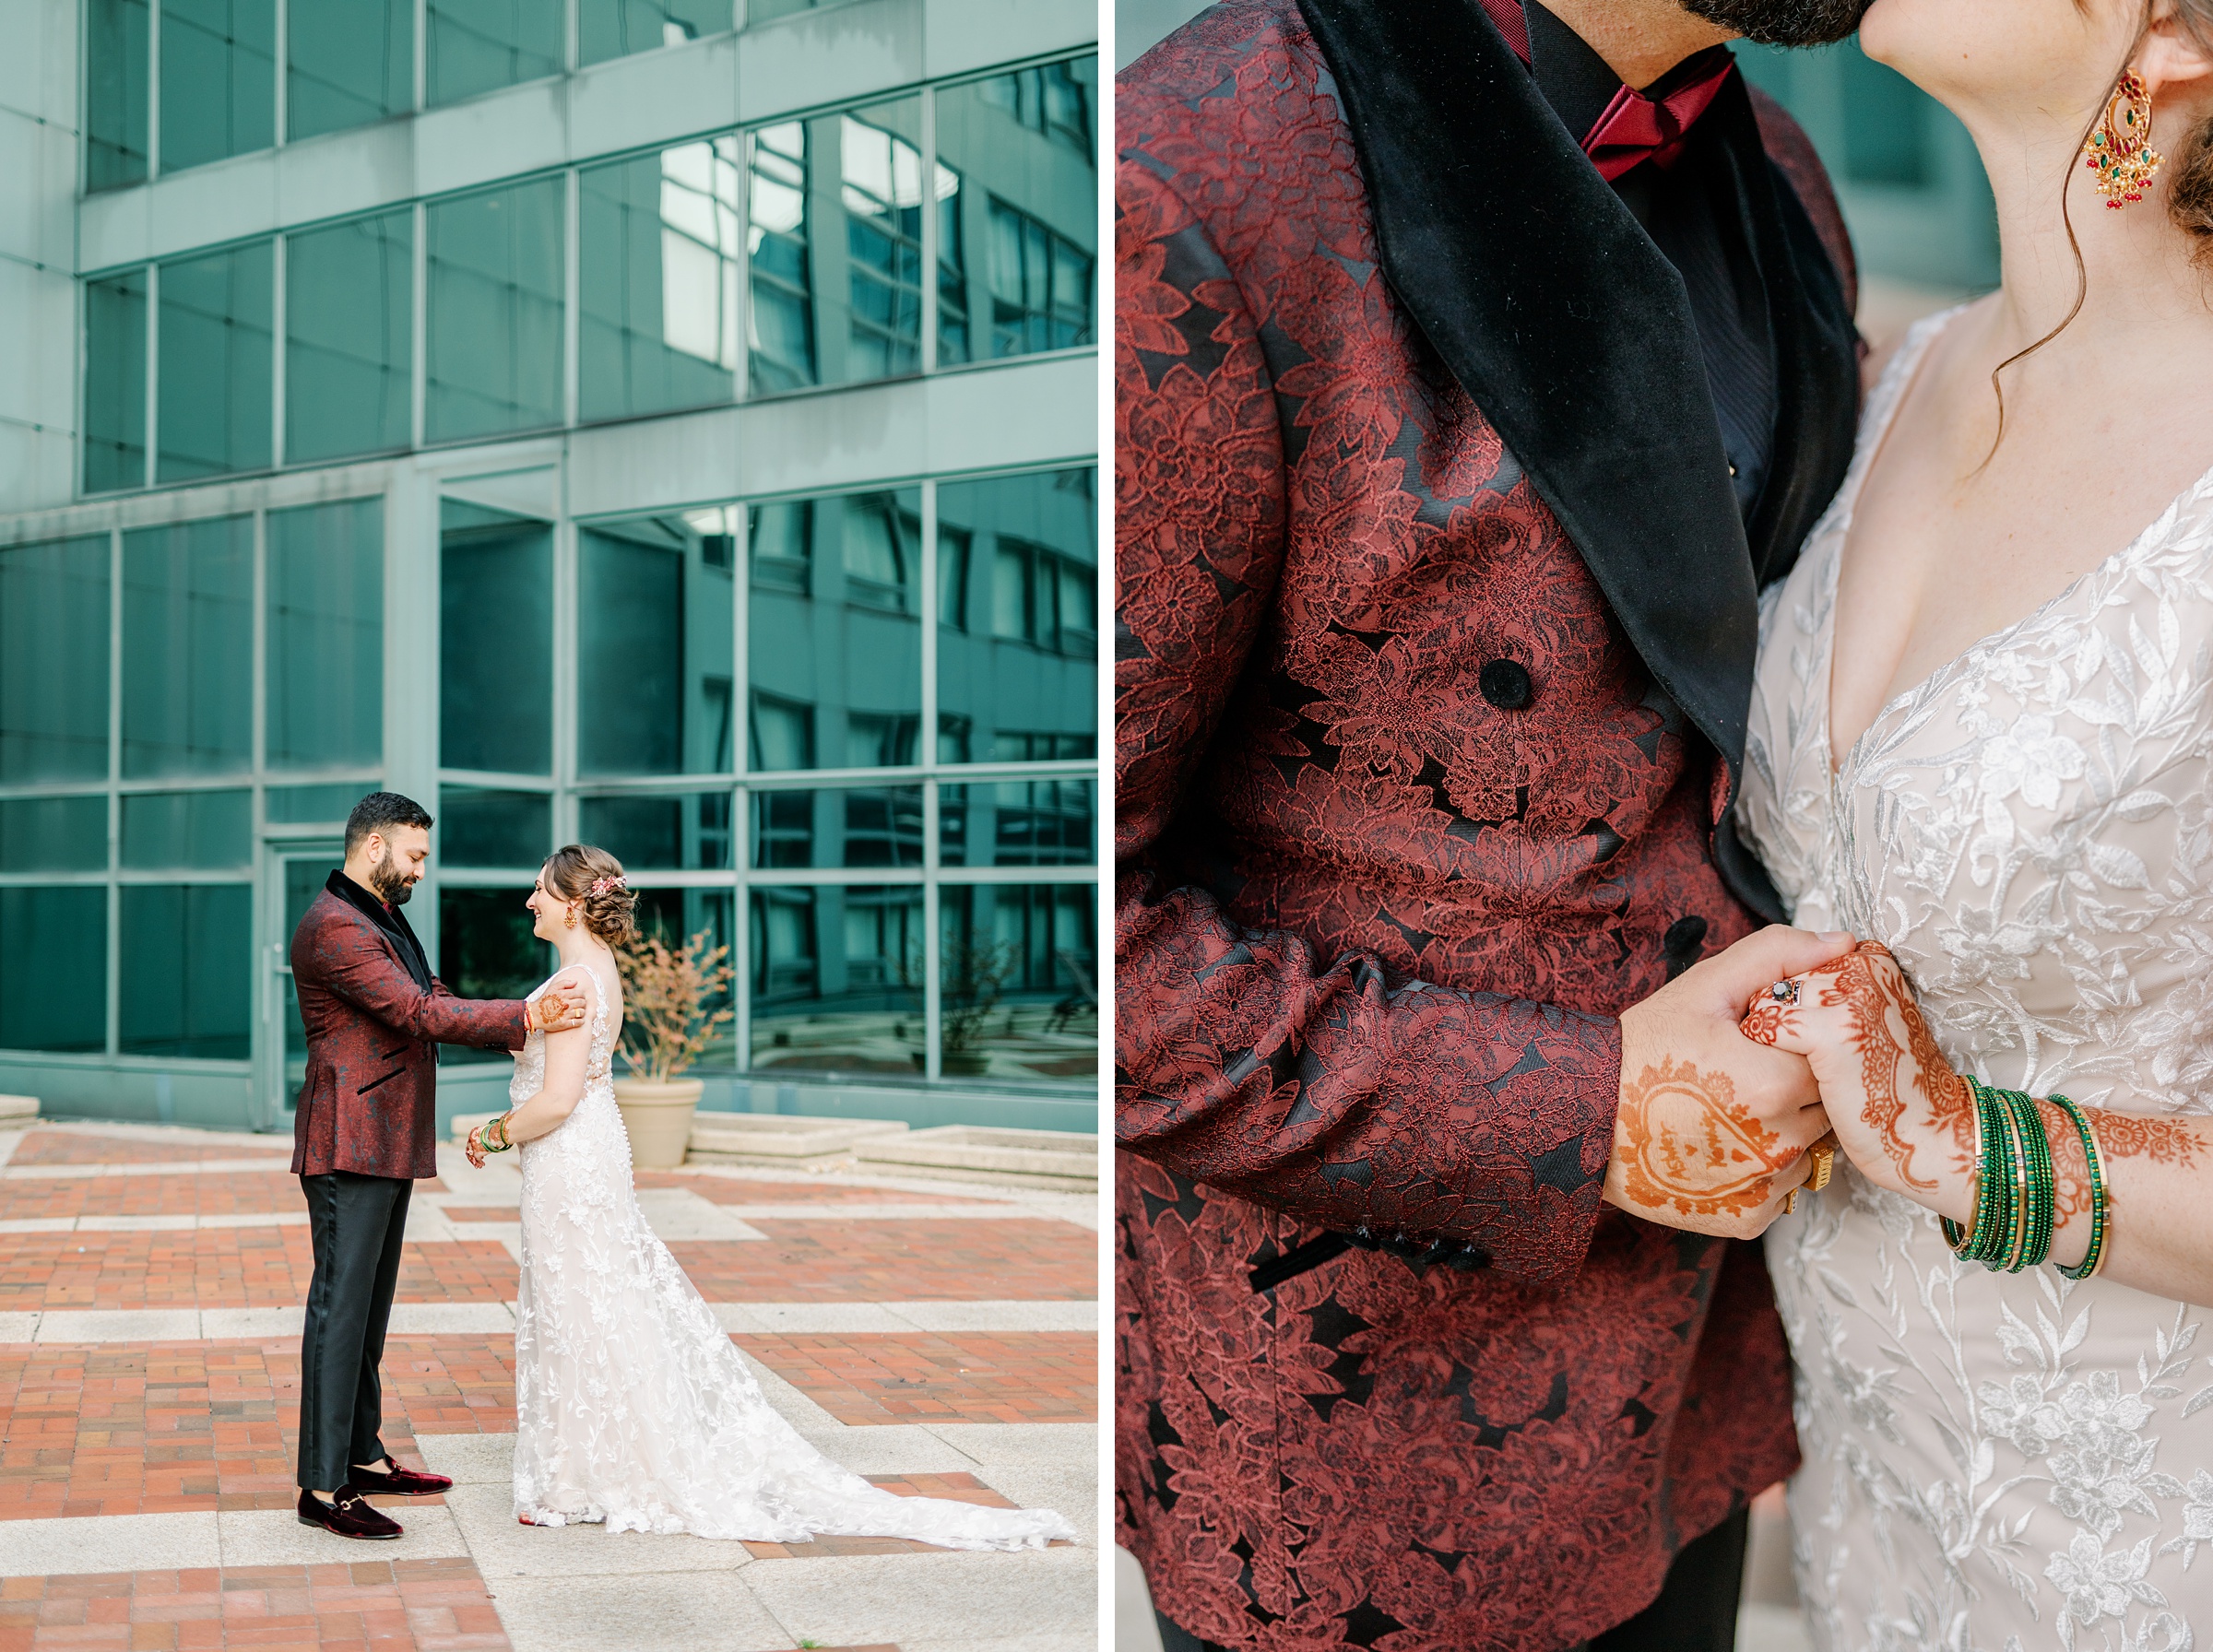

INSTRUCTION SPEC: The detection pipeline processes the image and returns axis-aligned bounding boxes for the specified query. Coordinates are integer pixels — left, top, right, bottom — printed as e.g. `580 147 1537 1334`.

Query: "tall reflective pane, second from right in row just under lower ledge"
746 489 923 772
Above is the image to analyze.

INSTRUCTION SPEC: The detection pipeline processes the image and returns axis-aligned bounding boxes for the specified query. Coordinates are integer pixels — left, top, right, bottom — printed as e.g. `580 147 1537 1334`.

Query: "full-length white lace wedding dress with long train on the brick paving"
509 969 1075 1548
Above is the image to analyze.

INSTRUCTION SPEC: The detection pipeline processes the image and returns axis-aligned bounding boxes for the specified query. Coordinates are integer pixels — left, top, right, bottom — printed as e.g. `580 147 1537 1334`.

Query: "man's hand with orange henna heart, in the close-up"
1606 925 1852 1238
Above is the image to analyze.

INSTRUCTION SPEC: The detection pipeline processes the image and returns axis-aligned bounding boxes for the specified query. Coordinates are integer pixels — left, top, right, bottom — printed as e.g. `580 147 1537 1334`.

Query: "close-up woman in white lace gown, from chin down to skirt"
1739 0 2213 1652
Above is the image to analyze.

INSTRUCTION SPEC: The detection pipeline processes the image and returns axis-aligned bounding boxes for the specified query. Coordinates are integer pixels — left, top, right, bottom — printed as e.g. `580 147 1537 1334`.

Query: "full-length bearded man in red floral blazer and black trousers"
292 792 585 1540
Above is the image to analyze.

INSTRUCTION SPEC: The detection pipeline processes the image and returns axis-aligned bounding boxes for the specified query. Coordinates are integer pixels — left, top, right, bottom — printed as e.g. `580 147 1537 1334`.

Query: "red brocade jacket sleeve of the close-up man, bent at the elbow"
1116 161 1620 1282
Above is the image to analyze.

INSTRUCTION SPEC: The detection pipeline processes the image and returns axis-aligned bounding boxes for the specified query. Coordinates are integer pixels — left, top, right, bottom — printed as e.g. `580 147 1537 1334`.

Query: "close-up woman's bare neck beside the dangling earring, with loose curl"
1959 100 2213 365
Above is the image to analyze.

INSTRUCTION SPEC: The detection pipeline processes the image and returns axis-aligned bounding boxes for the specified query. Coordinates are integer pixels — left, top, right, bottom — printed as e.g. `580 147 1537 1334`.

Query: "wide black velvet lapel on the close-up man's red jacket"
1299 0 1857 914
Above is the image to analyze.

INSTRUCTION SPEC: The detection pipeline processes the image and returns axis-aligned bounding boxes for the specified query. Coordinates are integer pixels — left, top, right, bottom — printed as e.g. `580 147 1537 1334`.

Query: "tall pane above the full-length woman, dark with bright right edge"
577 509 740 774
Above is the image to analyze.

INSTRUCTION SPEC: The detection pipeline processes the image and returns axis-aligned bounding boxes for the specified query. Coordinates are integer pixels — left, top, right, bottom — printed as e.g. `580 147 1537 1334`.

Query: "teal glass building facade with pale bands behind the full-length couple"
0 0 1102 1130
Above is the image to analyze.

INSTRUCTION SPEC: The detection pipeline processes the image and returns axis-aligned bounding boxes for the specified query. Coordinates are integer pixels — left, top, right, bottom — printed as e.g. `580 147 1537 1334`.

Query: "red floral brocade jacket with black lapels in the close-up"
1116 0 1857 1652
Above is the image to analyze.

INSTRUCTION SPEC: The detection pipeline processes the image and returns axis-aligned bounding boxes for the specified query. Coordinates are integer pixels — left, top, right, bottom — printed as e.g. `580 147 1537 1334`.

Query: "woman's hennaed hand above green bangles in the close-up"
1744 940 1974 1214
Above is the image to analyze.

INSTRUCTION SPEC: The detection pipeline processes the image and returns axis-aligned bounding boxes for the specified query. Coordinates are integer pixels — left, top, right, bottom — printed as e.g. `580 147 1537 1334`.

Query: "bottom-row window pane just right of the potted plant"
751 887 923 1077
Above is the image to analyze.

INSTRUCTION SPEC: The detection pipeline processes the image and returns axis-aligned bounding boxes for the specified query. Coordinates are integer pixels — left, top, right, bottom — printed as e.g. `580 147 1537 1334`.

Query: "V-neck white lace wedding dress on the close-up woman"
1742 316 2213 1652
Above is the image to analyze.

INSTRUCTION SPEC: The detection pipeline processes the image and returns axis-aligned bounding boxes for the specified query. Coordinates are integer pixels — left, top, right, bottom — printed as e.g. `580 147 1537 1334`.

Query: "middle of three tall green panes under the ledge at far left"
124 515 254 776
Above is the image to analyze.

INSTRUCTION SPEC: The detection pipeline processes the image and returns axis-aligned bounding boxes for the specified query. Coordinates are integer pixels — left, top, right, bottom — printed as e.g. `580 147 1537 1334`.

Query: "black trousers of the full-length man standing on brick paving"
299 1170 414 1491
